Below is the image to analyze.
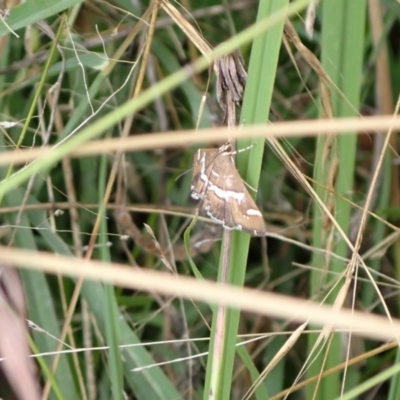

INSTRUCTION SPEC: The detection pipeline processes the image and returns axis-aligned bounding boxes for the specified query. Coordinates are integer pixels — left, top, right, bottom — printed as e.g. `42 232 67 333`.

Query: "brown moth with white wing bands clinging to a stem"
191 144 267 236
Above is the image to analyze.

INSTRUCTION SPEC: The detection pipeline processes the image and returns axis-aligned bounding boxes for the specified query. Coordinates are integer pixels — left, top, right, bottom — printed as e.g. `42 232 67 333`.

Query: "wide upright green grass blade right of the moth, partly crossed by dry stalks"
307 0 366 399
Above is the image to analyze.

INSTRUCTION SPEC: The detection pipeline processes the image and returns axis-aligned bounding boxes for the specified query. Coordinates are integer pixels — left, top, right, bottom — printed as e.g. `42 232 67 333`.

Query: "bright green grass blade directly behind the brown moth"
204 1 288 399
